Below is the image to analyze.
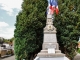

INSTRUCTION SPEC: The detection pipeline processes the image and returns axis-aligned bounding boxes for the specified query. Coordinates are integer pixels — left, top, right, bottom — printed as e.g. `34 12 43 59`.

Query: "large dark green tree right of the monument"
54 0 80 60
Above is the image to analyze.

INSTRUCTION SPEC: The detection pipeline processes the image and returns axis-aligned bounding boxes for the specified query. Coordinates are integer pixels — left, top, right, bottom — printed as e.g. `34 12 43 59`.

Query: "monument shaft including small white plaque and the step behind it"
38 14 61 55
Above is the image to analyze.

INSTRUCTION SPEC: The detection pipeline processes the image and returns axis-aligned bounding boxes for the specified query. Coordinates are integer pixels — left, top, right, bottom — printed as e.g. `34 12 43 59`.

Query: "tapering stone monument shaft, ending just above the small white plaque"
43 14 59 50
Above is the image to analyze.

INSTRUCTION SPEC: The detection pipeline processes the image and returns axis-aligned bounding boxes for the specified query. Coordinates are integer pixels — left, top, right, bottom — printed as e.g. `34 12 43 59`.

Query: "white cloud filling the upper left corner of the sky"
0 0 23 16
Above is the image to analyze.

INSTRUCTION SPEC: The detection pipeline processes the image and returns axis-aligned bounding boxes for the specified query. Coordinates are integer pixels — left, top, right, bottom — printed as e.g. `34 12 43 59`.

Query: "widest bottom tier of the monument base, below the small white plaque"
34 53 69 60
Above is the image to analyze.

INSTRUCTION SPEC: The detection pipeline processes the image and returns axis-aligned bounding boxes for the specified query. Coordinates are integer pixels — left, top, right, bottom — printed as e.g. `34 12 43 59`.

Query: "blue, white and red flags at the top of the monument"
47 0 59 15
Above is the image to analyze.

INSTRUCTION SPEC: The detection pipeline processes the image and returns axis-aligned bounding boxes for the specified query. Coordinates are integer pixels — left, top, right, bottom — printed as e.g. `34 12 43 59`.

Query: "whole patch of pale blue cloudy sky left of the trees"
0 0 23 39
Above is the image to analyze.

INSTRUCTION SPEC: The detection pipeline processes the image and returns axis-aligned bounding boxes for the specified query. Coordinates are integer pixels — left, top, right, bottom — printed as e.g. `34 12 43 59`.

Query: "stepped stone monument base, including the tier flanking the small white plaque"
34 50 69 60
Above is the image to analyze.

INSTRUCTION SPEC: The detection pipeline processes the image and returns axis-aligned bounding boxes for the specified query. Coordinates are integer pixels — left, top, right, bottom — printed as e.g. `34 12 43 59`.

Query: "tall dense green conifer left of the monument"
14 0 47 60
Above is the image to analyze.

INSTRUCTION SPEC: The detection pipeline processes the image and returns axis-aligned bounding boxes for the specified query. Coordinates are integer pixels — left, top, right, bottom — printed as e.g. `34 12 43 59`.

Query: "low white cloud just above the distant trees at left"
0 22 15 39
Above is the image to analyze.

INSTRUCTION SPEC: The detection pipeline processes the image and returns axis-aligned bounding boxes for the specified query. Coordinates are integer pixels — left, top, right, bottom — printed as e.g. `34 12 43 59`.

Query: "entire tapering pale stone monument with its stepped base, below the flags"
34 0 69 60
